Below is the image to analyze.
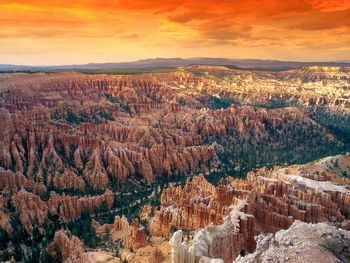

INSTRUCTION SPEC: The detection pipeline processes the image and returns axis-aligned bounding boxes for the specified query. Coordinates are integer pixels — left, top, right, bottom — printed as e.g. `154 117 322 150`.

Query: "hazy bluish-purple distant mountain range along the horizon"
0 57 350 70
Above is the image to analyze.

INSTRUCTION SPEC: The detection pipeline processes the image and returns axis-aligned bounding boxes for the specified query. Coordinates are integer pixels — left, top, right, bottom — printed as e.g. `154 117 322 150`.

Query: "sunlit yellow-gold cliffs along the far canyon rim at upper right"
184 66 350 108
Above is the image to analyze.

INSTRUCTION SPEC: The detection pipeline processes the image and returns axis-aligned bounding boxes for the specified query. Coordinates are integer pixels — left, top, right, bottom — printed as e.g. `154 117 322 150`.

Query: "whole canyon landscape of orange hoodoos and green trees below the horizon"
0 65 350 263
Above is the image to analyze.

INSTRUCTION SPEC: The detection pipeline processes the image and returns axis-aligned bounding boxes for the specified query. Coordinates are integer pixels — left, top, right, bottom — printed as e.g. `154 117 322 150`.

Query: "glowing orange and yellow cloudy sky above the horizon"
0 0 350 65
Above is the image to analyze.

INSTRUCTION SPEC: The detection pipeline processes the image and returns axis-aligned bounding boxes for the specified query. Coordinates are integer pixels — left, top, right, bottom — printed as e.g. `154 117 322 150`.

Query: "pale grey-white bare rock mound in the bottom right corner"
234 221 350 263
